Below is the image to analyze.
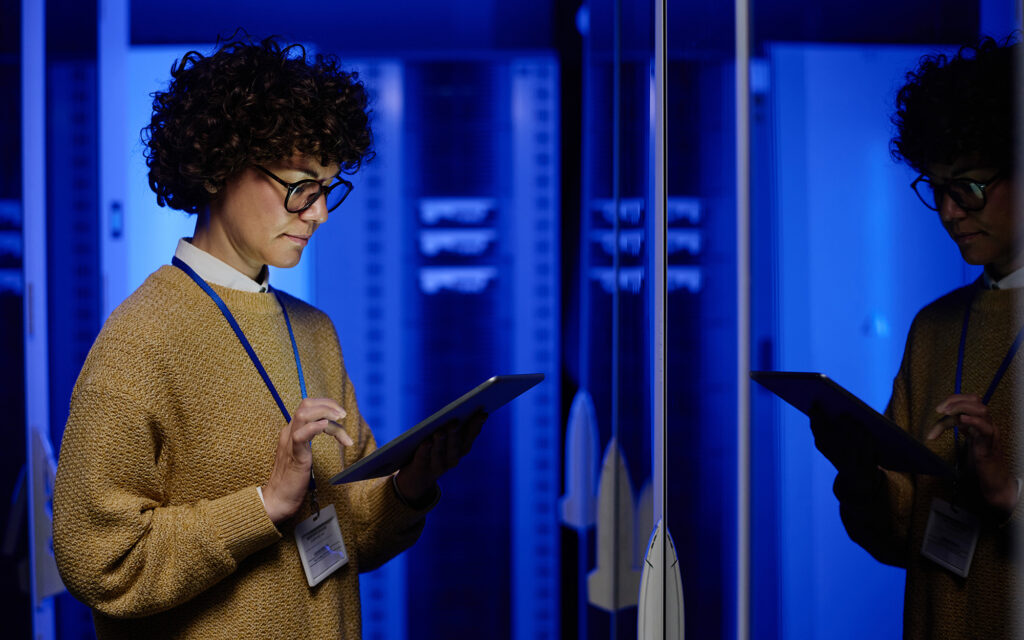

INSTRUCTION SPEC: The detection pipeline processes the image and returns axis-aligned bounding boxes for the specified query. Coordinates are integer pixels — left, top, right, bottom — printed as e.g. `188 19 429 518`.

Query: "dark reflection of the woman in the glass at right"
813 40 1024 638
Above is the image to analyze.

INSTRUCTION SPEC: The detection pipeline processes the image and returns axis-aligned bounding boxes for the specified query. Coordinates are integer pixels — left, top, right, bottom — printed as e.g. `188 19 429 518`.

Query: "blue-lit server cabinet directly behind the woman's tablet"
312 57 560 638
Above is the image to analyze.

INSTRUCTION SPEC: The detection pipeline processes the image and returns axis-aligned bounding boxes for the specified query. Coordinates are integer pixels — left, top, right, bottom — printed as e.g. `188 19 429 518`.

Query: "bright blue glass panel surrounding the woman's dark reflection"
751 0 1019 638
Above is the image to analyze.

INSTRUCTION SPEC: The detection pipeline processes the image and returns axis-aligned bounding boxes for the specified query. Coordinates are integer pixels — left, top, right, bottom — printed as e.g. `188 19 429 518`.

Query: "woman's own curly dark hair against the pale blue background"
142 37 373 213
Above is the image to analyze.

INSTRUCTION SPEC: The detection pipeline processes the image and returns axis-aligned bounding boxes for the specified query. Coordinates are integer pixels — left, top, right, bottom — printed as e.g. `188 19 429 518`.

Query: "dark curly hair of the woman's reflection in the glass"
889 36 1020 173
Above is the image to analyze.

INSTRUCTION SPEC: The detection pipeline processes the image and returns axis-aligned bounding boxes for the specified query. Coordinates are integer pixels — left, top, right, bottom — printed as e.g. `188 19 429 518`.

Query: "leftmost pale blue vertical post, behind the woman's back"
22 0 54 640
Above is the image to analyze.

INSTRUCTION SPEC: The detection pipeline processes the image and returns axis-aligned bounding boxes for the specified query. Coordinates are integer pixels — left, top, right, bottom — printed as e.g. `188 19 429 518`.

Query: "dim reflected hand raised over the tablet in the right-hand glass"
927 394 1019 511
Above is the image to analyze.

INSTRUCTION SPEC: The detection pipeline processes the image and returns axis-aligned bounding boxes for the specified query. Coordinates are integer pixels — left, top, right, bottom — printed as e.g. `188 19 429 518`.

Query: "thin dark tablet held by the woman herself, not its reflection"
331 374 544 484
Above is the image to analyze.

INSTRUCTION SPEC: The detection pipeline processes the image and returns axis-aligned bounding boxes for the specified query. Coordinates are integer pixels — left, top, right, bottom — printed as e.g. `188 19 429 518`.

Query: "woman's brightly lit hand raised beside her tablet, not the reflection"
262 397 352 524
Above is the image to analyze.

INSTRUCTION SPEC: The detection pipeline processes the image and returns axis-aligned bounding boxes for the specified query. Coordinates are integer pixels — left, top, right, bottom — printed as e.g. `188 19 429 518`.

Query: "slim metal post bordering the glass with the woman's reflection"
735 0 751 640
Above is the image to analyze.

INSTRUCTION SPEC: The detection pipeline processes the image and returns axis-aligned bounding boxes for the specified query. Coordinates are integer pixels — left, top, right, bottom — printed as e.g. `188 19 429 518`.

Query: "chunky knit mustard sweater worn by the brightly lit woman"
53 266 425 639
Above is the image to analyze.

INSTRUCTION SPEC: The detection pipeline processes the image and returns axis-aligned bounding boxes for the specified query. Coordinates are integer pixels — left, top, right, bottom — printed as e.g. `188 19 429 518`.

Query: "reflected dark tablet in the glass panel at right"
751 371 953 476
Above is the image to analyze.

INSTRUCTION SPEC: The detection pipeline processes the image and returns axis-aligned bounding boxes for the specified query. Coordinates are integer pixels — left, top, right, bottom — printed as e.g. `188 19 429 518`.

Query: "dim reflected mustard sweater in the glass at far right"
836 283 1024 640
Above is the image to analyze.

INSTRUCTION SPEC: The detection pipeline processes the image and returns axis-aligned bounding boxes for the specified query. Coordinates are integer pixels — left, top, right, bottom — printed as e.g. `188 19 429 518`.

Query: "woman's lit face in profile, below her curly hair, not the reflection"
197 154 339 279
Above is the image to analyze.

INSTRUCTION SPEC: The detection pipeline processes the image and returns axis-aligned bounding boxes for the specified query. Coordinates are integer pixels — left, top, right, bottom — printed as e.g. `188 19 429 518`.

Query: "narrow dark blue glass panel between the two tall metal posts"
666 2 737 638
